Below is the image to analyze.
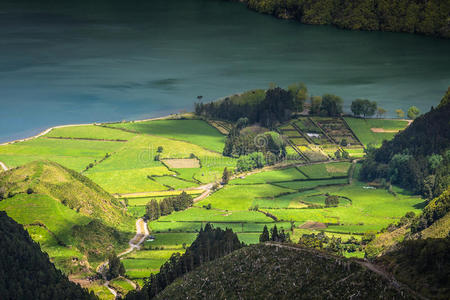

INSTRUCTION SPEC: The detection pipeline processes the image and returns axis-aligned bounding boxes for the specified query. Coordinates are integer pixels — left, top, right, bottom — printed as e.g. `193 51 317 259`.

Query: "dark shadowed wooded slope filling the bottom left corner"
0 212 96 299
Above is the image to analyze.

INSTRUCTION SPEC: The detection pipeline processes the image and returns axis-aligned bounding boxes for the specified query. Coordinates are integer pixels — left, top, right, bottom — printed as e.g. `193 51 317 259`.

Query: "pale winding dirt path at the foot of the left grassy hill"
97 218 150 297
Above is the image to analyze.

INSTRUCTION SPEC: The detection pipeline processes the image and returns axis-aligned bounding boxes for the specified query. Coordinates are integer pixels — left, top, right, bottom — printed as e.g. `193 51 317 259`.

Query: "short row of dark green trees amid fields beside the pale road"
144 191 194 221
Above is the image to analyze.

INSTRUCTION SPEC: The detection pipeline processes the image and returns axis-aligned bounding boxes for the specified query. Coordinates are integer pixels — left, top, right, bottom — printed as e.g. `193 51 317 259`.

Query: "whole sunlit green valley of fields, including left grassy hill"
0 102 424 299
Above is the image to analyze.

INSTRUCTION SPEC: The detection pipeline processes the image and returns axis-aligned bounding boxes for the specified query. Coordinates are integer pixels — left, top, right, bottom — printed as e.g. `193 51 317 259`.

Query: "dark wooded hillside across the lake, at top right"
236 0 450 38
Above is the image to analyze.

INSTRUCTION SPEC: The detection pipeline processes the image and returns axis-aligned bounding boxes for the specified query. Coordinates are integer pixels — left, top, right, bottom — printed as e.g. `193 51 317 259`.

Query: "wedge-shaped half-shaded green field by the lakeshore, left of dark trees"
107 119 225 153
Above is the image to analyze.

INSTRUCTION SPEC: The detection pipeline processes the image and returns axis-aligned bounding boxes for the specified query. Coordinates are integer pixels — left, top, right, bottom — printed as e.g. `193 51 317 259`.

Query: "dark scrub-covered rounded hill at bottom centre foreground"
157 244 415 299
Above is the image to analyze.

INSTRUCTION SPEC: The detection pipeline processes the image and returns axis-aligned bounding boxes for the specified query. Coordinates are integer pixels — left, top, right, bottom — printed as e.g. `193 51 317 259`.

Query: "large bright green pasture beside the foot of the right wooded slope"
261 181 424 233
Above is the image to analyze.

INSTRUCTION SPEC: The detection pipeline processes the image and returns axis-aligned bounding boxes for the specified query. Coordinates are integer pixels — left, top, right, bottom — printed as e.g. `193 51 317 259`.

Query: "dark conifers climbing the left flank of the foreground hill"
125 223 244 300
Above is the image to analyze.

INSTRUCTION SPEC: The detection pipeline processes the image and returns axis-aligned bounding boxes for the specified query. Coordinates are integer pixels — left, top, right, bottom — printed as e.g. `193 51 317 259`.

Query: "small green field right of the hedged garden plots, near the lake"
345 117 408 147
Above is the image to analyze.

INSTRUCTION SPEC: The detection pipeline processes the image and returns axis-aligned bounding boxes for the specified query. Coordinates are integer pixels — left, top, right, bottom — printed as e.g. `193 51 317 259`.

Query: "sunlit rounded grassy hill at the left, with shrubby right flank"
0 161 134 273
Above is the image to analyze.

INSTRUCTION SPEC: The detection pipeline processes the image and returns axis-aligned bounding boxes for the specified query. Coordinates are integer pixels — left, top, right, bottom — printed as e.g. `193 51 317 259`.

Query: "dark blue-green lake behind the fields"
0 0 450 141
